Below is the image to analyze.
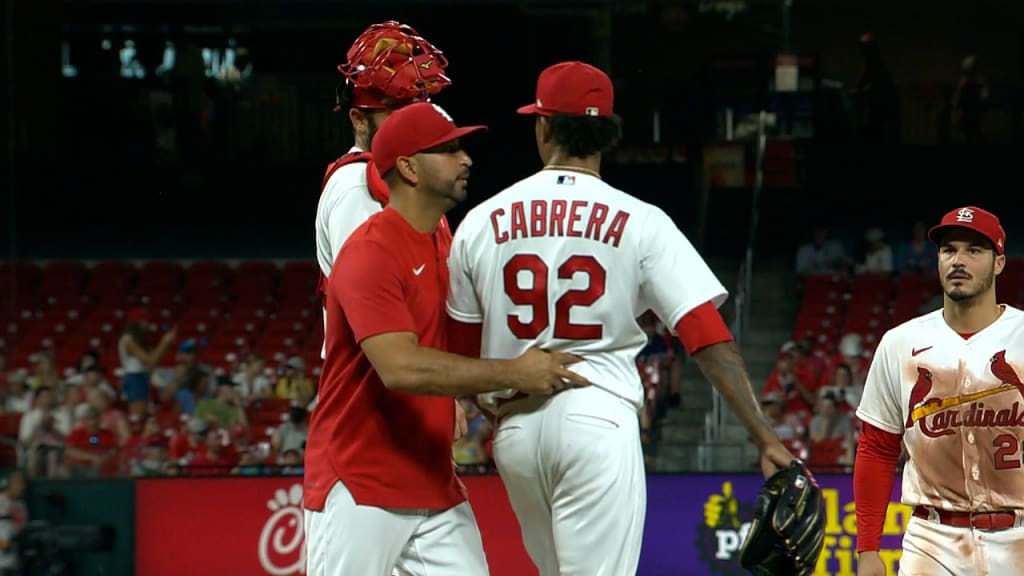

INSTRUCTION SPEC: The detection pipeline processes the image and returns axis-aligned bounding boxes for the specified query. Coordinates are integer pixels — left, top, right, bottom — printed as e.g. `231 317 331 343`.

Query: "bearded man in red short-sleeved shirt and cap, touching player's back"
303 102 587 576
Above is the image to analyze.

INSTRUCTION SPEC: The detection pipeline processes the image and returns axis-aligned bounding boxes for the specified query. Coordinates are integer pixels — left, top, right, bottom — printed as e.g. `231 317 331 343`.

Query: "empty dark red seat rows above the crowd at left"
0 256 324 376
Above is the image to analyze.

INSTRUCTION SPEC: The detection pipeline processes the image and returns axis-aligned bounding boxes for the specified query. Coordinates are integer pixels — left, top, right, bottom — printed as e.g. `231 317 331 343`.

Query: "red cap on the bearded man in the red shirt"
370 102 487 175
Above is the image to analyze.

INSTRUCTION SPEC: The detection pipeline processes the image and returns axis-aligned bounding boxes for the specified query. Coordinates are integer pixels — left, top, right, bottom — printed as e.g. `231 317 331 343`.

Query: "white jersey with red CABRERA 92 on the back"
447 169 727 409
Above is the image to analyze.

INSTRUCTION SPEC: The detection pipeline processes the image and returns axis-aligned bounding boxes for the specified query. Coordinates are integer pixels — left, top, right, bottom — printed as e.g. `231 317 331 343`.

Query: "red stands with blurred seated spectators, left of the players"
0 261 680 478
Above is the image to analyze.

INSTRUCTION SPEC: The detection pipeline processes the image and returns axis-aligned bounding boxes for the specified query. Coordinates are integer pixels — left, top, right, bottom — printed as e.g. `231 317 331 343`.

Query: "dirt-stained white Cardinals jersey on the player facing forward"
857 305 1024 511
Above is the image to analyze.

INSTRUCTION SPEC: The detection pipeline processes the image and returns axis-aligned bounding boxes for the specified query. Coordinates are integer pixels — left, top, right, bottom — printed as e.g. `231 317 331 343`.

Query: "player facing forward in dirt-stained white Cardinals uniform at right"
854 206 1024 576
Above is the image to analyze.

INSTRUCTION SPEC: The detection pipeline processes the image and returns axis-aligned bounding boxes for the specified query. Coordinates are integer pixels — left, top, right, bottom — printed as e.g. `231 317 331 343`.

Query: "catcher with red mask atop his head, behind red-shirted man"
315 20 452 354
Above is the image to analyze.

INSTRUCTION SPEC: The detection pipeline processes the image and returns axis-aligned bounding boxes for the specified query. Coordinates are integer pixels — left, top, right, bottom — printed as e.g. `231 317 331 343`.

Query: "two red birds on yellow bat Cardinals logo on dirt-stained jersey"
906 349 1024 438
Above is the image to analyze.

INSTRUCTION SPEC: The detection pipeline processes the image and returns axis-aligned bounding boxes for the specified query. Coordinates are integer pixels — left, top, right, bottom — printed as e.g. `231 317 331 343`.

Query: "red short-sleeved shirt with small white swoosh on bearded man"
304 207 465 510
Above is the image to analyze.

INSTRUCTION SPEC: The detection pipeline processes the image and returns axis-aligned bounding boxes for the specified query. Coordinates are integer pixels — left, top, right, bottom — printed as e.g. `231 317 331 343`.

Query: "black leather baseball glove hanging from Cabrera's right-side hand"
739 460 825 576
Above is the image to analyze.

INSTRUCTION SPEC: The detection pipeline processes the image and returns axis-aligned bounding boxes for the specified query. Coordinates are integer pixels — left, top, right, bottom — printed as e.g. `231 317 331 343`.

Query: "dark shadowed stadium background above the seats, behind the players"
0 0 1024 257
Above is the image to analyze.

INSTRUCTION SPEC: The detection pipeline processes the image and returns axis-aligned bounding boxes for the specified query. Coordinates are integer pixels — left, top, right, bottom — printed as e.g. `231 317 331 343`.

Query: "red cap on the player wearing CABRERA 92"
518 60 615 117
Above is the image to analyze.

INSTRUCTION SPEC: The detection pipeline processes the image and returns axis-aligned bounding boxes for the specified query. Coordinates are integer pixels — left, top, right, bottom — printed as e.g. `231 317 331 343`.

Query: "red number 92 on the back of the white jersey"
503 254 606 340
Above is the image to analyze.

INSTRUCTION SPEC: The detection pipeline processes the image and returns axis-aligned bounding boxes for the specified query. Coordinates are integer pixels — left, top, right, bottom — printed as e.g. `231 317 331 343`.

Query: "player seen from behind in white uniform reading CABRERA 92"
447 61 793 576
